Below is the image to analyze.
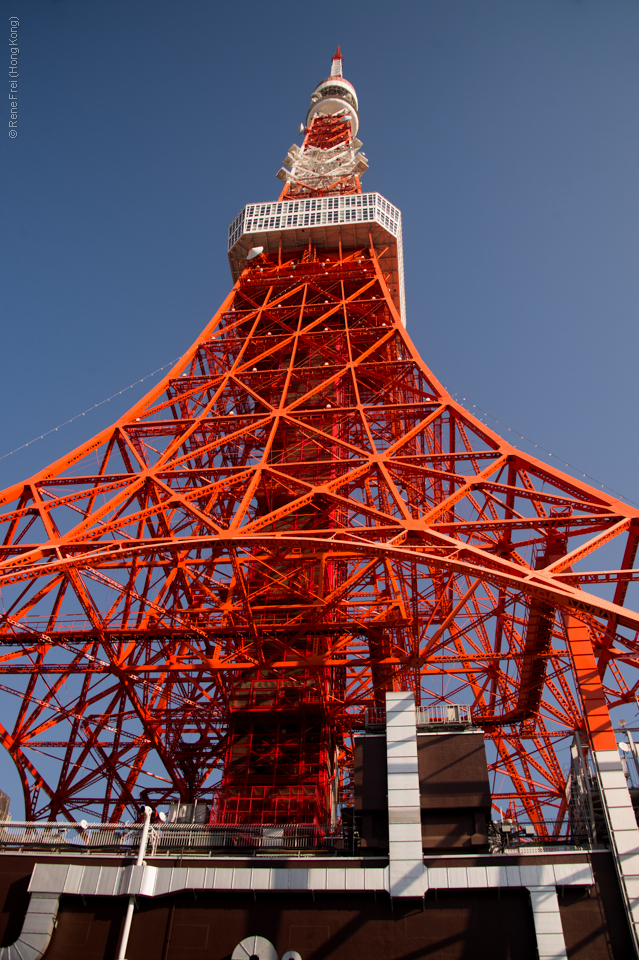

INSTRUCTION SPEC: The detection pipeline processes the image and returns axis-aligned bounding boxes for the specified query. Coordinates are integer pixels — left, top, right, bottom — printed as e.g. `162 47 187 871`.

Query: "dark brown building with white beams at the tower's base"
0 692 633 960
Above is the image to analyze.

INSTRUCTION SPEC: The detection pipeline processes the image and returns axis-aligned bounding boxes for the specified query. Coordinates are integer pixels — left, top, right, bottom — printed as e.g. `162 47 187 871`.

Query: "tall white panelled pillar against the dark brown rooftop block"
386 692 426 897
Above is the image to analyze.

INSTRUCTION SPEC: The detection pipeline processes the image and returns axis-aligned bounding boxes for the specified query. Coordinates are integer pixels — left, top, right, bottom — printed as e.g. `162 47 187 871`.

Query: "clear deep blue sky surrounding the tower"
0 0 639 808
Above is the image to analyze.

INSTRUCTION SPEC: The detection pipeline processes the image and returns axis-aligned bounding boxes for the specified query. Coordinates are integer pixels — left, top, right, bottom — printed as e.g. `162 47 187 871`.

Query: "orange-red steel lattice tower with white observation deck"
0 50 639 834
